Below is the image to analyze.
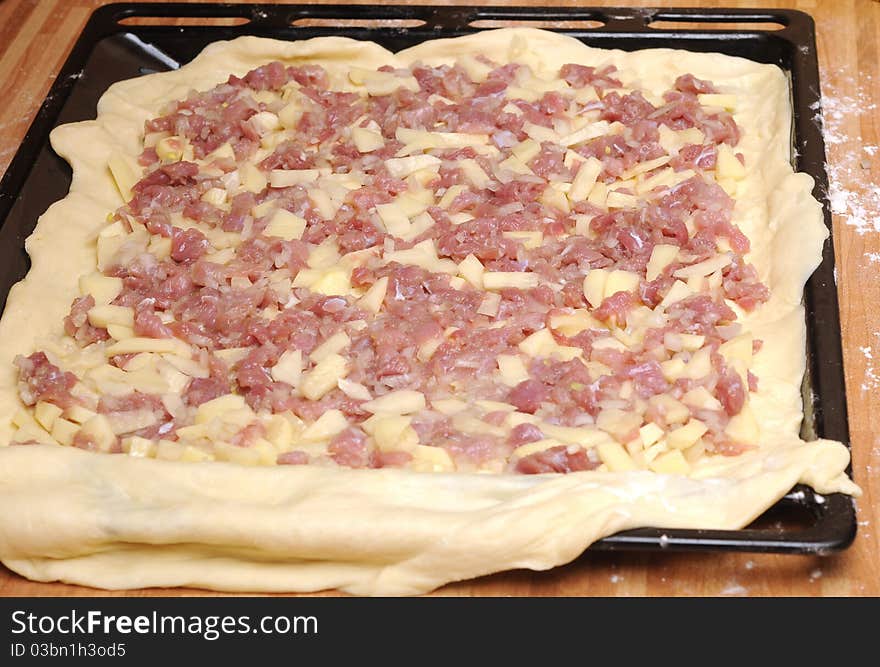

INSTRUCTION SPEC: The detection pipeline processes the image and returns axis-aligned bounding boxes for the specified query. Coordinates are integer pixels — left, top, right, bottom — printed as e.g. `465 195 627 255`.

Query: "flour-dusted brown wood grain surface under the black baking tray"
0 0 880 596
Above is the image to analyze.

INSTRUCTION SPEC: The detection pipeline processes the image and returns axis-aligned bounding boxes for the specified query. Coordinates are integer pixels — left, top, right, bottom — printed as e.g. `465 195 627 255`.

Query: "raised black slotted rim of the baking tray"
0 2 857 555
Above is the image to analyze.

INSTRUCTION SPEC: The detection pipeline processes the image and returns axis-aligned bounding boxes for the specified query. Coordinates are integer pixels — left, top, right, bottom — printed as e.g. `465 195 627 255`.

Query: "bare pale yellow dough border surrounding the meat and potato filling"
0 29 858 595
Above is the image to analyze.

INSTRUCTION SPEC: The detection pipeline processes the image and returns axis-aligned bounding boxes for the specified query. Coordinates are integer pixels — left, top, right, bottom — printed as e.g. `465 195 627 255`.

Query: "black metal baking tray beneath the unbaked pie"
0 3 856 554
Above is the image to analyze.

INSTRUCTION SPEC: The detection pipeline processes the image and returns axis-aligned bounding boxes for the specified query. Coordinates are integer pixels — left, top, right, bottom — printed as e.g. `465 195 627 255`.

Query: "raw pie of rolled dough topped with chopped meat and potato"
0 30 857 594
